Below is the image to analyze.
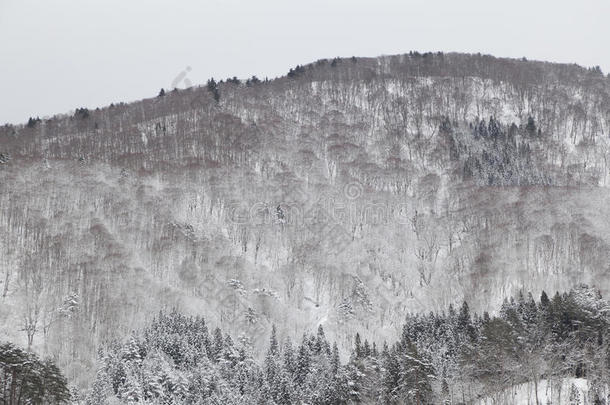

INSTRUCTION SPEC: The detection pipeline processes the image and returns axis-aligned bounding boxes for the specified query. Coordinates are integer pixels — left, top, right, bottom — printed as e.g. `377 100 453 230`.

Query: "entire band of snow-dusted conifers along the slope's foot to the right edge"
78 286 610 405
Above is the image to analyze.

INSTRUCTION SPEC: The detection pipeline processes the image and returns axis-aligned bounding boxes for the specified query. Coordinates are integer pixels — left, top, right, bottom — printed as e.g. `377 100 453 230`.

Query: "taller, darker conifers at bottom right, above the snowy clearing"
403 286 610 404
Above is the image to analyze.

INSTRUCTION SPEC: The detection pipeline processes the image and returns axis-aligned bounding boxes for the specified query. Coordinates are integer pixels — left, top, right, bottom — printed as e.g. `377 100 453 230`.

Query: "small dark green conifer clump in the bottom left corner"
0 343 70 405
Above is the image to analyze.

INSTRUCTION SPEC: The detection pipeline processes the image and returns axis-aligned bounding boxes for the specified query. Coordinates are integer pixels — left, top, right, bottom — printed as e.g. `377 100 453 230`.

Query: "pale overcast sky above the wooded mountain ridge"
0 0 610 124
